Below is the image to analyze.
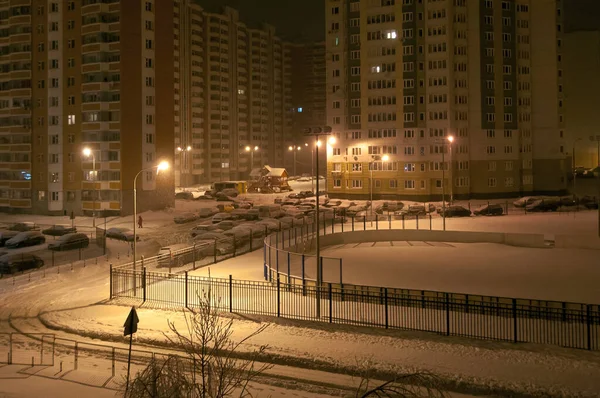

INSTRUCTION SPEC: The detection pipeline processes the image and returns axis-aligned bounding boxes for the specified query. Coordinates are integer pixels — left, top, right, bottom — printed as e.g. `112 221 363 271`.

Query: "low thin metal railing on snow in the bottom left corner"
0 333 188 390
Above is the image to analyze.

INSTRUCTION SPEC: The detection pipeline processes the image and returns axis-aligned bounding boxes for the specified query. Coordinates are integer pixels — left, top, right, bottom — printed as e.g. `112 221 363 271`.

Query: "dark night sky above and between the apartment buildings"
196 0 600 42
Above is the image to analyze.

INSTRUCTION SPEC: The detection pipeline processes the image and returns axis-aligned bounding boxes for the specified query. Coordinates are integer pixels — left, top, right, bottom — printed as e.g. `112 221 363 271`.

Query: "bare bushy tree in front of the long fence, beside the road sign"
124 290 273 398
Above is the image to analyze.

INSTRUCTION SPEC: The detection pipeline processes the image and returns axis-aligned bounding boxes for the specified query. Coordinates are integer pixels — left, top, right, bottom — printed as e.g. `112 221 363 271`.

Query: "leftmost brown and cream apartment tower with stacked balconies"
0 0 175 215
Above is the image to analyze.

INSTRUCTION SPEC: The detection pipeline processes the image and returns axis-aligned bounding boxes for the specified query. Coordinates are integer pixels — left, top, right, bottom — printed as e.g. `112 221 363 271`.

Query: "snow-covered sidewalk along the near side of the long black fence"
41 302 600 397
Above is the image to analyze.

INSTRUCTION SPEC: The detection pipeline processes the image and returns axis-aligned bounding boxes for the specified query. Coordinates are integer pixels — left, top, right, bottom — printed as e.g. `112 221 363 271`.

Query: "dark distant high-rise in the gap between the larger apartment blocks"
284 42 327 175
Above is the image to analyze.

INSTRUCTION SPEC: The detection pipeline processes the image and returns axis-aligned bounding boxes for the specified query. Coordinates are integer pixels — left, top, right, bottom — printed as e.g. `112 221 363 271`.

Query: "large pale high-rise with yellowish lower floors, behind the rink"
325 0 566 200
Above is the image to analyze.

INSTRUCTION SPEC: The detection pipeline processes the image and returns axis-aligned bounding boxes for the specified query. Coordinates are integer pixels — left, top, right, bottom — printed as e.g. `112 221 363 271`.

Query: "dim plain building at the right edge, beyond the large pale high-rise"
564 30 600 168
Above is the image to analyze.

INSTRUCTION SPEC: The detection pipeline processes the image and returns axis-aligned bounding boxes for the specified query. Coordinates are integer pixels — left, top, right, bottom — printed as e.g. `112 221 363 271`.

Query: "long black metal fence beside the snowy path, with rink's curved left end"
110 224 600 350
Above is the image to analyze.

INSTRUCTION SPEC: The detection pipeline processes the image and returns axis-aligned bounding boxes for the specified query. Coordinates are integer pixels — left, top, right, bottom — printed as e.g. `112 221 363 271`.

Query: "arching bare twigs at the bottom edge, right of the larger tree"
355 361 448 398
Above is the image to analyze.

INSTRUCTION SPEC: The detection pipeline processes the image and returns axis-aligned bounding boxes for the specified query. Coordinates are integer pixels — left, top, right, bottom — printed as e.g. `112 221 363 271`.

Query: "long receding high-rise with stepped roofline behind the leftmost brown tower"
175 0 292 186
